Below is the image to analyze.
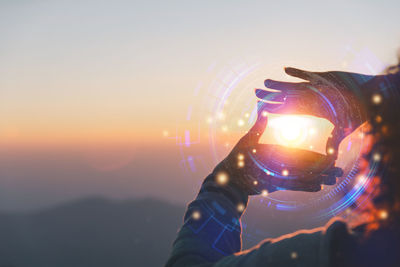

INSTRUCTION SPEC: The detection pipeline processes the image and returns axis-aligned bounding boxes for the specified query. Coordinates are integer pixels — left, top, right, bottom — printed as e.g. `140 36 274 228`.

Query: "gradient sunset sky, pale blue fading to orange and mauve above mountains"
0 0 400 214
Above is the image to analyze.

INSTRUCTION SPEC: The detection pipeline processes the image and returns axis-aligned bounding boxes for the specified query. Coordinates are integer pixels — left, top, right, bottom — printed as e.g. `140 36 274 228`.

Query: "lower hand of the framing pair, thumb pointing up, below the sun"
214 103 343 195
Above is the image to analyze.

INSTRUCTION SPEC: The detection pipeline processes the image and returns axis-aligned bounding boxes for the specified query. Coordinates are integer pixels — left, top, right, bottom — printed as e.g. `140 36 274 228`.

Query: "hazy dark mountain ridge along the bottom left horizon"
0 198 185 267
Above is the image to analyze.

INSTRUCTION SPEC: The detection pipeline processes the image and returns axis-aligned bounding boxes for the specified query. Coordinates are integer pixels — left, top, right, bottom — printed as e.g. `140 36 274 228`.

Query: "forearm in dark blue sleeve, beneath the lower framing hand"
167 172 248 266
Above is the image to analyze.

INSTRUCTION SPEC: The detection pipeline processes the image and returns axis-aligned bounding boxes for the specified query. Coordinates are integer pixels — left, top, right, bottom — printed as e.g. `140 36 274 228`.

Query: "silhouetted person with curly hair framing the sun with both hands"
166 61 400 267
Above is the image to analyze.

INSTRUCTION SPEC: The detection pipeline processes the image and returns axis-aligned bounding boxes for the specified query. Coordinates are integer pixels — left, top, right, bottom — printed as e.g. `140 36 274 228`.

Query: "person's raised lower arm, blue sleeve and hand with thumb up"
162 102 340 267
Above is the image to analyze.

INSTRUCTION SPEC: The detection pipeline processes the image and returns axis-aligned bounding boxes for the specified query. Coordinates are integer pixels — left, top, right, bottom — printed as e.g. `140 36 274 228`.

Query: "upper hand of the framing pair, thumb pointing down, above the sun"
256 68 390 158
